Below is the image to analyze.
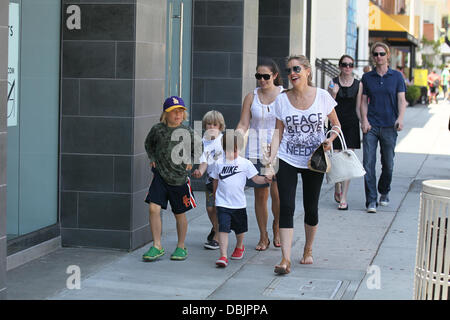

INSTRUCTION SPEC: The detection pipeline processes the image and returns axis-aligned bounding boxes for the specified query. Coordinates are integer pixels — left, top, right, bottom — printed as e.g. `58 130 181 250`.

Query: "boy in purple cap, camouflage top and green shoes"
142 96 201 261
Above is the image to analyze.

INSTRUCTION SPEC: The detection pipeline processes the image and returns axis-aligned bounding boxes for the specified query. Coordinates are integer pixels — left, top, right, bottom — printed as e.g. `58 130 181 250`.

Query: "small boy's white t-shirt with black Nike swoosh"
211 156 258 209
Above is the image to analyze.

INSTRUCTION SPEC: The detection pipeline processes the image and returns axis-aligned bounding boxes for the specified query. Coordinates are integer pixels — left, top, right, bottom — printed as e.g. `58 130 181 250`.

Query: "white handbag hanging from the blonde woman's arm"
326 126 366 184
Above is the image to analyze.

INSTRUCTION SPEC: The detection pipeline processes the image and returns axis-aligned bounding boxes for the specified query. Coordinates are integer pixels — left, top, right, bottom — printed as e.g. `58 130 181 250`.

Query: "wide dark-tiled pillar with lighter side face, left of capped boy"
60 0 166 250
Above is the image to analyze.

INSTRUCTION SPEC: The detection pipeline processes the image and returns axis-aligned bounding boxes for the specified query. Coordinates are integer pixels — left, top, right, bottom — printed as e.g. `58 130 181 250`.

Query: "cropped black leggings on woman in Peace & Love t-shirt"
277 159 324 228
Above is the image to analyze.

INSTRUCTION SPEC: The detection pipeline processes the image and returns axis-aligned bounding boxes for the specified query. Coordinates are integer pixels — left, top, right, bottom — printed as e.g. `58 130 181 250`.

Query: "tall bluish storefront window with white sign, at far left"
6 0 61 240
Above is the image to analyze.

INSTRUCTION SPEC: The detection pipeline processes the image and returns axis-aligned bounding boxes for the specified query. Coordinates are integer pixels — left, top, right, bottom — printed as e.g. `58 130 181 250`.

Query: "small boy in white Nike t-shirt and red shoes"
211 131 270 267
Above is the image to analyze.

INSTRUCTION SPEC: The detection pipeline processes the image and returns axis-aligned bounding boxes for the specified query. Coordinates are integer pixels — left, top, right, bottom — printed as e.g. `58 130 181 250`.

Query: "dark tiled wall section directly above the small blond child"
192 0 250 128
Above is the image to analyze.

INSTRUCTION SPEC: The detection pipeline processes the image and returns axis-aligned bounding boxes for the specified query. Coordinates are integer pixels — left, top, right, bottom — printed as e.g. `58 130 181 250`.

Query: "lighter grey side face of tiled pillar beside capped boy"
130 0 167 249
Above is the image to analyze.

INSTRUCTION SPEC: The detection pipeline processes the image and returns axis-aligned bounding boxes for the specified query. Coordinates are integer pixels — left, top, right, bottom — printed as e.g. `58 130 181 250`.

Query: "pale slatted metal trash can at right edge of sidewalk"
414 180 450 300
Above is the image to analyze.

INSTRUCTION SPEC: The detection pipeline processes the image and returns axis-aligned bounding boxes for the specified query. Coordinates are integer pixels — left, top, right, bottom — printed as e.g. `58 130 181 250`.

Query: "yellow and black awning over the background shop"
369 2 419 46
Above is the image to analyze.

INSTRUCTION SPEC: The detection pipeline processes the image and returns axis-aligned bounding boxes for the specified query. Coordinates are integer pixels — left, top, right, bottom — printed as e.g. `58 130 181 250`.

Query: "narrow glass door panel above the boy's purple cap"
166 0 192 115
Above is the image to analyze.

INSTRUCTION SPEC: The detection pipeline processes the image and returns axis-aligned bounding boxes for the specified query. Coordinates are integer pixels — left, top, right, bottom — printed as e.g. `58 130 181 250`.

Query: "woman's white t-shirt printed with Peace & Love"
275 88 337 168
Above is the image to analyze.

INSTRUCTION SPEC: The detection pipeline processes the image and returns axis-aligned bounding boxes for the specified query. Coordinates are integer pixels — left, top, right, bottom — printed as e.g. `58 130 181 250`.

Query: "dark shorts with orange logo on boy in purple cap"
145 170 197 214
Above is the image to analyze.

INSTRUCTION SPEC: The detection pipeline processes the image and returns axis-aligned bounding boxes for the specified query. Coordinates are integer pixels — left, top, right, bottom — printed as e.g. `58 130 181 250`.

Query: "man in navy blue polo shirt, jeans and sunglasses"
361 42 407 213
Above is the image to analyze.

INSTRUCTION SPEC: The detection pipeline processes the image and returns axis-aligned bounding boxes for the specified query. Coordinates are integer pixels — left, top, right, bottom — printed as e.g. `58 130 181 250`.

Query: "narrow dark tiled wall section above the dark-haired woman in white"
258 0 290 88
